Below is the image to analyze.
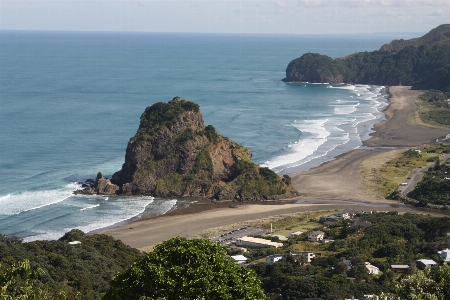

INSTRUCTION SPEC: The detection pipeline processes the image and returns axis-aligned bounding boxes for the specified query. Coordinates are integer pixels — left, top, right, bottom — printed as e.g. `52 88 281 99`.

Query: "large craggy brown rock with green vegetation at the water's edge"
86 97 297 201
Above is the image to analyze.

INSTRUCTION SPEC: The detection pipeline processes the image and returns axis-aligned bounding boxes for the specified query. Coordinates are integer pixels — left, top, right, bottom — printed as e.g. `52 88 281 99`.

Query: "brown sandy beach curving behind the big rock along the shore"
100 86 450 250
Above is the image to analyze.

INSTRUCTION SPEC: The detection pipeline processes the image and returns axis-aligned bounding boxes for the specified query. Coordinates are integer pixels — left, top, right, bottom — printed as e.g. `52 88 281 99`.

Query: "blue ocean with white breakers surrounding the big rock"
0 31 418 241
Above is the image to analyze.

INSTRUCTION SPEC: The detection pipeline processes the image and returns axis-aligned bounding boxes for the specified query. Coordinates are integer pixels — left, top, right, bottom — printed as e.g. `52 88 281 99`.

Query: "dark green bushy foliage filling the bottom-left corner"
0 230 141 299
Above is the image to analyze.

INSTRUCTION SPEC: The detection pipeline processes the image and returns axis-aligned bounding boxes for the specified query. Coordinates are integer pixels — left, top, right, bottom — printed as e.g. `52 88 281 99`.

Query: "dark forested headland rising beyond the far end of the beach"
283 24 450 91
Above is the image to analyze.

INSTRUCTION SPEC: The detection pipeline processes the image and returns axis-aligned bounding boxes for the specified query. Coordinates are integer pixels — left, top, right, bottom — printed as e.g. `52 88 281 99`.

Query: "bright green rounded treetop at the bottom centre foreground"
104 237 267 300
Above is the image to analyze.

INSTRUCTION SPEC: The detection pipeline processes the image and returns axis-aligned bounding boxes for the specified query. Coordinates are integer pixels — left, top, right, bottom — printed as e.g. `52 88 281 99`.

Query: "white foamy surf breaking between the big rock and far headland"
262 84 386 174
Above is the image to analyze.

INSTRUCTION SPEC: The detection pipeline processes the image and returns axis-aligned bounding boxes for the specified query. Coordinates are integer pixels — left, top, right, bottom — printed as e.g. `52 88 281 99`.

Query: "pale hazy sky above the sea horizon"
0 0 450 34
